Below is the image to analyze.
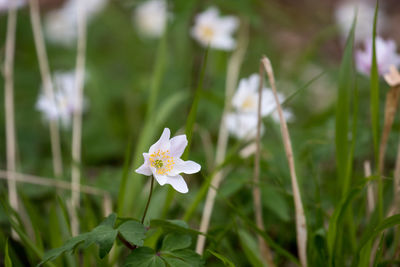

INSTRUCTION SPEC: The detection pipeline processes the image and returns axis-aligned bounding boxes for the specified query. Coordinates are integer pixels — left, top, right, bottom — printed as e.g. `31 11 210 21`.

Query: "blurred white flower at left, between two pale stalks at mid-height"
36 71 84 127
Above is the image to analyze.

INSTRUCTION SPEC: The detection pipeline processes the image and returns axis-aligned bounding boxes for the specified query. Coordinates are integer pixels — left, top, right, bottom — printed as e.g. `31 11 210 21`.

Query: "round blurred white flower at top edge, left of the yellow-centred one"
133 0 168 38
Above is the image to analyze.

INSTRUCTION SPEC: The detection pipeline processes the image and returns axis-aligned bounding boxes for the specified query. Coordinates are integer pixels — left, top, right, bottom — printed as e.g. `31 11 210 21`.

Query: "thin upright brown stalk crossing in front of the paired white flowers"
253 64 275 266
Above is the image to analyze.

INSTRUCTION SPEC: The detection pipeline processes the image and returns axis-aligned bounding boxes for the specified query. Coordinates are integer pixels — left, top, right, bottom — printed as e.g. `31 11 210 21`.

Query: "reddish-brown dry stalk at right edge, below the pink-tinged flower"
379 87 400 175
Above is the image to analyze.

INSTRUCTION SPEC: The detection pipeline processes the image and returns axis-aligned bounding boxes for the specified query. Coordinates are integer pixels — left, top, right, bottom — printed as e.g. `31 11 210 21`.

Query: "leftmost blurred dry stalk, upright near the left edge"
4 5 18 237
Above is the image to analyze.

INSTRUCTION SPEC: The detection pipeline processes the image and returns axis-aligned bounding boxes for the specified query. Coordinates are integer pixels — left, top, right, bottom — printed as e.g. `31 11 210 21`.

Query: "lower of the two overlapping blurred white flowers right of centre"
225 113 264 141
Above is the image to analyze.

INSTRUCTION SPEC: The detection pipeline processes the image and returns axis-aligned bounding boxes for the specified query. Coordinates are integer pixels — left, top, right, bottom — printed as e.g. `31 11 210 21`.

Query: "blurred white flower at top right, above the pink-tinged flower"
335 1 385 42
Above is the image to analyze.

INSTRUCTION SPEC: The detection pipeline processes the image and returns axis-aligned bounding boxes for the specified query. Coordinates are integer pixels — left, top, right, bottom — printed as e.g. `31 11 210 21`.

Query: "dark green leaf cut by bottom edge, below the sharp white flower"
123 247 165 267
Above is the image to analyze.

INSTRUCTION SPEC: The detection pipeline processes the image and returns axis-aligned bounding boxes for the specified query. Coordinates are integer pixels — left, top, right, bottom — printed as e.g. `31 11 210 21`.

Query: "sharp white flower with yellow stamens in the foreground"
136 128 201 193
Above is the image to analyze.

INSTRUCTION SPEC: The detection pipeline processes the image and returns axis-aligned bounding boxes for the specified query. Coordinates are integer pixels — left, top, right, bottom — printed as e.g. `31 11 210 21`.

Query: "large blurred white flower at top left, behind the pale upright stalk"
44 0 107 47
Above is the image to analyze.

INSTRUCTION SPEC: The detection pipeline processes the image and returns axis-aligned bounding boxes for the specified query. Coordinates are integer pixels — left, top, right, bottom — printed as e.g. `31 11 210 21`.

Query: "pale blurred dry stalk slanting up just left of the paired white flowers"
196 23 248 255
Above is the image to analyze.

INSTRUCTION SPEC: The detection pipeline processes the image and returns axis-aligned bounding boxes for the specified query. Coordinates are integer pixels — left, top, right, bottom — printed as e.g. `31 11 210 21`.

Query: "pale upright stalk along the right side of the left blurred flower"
71 1 86 235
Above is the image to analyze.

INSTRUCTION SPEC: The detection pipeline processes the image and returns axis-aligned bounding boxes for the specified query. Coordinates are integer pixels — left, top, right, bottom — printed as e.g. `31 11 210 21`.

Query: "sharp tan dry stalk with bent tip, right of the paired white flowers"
262 56 307 267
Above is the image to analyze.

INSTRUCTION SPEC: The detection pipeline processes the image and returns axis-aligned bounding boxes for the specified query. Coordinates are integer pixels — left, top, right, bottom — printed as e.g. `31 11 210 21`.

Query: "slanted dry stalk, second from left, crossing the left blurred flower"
29 0 63 179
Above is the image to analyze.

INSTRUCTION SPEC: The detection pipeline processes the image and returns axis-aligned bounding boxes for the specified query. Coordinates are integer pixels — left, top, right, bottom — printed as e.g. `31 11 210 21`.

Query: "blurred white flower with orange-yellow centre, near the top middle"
191 7 239 50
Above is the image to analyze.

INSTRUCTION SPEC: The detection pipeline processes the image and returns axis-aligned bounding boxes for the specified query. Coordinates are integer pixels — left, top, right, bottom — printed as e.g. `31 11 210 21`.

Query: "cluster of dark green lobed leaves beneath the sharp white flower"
38 216 204 267
